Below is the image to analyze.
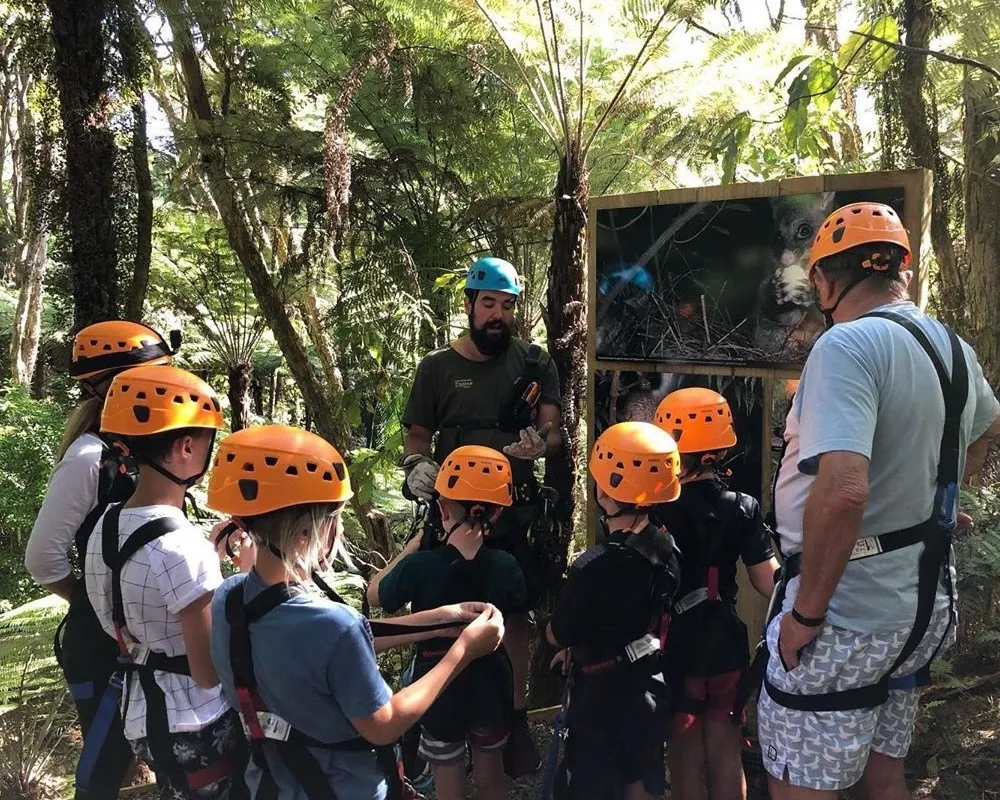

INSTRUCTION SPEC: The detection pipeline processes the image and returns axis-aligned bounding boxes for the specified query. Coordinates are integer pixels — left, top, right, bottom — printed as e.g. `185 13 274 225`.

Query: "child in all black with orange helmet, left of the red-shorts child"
546 422 681 800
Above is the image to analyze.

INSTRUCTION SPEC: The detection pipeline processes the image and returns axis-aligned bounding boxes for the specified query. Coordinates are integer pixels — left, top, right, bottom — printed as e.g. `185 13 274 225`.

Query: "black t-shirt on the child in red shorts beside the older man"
651 480 774 605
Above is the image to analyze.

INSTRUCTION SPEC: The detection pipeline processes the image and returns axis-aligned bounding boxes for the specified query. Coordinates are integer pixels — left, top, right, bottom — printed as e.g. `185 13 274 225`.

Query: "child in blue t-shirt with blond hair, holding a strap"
208 432 503 800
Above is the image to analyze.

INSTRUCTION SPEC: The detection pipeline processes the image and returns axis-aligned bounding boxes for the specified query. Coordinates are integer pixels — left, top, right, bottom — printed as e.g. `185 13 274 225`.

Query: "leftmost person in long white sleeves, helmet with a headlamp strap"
24 320 179 800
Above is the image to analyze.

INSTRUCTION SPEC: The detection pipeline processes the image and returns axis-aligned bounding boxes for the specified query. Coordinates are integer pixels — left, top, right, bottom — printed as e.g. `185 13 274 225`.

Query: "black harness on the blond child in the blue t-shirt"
226 575 414 800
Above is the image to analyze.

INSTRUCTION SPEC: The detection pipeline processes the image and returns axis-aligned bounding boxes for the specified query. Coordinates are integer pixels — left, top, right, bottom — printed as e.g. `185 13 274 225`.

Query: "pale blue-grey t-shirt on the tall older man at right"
775 301 1000 633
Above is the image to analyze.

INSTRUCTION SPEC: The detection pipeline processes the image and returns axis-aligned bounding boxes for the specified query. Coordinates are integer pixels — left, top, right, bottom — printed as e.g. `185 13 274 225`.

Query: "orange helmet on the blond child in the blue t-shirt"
208 425 354 517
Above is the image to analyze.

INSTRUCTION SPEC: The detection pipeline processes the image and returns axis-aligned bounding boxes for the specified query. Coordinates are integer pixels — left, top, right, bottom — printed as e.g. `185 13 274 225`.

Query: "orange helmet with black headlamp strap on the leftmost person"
69 319 180 381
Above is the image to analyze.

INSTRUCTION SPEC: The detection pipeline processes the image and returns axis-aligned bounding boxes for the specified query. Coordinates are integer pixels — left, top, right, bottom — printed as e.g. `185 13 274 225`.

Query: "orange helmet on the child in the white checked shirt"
101 365 225 437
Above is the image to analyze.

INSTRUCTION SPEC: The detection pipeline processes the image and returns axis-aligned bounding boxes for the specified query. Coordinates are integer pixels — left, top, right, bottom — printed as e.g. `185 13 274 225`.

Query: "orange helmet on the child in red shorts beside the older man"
656 386 736 453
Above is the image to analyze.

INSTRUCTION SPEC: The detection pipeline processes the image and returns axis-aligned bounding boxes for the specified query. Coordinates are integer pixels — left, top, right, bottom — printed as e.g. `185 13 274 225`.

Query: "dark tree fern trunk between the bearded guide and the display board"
530 146 590 706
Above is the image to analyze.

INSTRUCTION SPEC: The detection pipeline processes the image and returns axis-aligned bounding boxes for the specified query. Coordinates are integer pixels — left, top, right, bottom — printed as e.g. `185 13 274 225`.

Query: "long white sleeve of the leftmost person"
24 433 104 586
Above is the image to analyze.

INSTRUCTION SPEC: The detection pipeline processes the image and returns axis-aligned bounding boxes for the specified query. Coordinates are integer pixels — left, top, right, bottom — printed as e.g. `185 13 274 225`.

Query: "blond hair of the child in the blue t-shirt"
244 503 350 575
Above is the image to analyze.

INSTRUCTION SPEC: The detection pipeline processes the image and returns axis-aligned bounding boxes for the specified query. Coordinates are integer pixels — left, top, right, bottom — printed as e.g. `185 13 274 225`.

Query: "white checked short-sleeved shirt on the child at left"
86 506 229 741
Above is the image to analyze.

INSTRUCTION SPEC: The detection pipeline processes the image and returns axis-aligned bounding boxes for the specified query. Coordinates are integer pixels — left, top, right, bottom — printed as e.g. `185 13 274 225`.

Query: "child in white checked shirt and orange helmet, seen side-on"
81 366 246 800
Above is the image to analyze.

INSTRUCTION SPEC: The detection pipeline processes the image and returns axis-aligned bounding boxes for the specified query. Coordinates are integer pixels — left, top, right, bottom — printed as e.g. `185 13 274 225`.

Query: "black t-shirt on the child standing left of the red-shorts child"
551 526 679 660
